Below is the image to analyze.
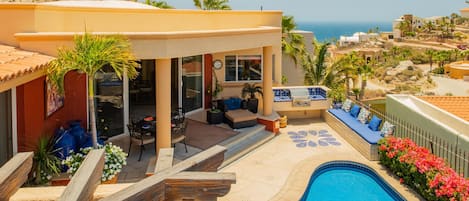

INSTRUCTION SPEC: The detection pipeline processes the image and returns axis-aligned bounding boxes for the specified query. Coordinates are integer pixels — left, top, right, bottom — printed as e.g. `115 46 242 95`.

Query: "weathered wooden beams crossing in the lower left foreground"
0 145 236 201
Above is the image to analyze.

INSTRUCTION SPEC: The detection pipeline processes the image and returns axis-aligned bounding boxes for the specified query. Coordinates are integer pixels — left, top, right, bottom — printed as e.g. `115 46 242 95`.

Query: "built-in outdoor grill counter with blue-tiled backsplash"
272 86 330 116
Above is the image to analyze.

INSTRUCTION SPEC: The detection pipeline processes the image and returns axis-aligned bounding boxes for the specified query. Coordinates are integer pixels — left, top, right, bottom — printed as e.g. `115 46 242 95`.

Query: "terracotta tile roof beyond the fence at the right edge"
419 96 469 122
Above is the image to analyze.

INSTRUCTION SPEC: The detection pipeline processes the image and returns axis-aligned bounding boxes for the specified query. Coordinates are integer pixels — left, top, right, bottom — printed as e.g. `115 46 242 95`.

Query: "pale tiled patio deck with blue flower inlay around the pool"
219 119 420 201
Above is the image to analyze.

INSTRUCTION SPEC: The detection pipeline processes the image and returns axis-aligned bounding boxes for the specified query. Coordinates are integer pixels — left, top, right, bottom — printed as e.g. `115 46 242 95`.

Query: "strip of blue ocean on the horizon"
296 21 392 42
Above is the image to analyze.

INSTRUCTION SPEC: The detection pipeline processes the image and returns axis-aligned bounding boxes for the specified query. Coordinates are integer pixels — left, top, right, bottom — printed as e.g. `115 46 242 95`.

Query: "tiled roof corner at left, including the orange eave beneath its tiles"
0 45 54 92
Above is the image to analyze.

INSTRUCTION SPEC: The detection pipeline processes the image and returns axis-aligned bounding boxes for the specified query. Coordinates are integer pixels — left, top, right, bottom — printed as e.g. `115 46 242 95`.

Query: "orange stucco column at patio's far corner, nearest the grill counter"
262 46 274 116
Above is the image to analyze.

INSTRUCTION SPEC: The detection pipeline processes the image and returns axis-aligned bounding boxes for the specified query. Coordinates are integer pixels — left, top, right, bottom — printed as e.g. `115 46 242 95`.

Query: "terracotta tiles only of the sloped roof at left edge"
0 44 54 83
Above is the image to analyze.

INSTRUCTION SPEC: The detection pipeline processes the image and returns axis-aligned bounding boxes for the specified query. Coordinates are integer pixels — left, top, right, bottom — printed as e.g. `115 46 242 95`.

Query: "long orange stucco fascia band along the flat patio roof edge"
15 26 282 59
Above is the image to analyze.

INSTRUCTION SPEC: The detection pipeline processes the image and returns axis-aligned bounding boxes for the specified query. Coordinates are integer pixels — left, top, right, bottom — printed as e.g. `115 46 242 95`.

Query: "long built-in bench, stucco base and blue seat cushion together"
324 109 382 161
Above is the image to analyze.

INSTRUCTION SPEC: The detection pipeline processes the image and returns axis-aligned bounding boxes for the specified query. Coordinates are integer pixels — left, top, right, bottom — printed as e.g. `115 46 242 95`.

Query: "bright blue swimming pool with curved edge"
301 161 405 201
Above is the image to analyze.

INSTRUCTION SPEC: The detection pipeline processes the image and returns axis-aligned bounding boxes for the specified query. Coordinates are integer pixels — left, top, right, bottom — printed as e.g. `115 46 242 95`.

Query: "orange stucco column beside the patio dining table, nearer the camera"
155 59 171 153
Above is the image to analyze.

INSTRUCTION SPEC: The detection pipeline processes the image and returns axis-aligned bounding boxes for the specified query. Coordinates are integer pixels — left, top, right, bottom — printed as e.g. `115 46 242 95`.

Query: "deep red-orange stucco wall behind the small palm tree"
16 72 87 152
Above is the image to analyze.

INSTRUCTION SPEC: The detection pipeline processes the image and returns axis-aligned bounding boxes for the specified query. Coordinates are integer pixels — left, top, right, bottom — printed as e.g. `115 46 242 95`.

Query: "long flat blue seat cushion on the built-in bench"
329 109 382 144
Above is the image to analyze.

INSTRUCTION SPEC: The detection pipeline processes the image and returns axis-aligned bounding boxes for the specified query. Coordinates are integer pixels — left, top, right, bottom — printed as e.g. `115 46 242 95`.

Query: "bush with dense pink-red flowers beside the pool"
378 137 469 201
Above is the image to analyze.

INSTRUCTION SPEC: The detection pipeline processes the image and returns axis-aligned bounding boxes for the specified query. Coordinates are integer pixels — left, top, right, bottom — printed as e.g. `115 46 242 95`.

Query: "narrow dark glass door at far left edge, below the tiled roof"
0 90 13 166
